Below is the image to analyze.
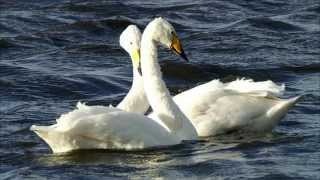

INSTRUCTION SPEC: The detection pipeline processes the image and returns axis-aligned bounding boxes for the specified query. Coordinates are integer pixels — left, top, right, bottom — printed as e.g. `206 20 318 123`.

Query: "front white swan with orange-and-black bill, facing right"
30 19 197 153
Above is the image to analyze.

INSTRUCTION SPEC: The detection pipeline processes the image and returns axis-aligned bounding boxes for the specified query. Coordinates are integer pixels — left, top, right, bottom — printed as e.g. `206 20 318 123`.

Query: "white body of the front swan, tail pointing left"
31 103 180 153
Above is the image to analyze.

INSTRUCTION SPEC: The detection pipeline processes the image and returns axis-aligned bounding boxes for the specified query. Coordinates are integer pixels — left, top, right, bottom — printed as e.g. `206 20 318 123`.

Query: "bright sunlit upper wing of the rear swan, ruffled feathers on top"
173 79 284 118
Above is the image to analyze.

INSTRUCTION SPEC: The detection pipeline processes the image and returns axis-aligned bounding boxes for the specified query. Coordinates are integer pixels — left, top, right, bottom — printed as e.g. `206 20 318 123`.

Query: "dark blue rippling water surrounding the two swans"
0 0 320 179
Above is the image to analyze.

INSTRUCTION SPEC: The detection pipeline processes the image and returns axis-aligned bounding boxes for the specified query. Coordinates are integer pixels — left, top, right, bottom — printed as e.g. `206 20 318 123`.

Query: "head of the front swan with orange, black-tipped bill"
148 17 188 61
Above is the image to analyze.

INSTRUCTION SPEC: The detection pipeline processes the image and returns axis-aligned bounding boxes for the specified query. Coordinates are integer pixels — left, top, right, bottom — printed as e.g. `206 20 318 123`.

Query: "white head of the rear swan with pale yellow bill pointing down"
119 25 142 75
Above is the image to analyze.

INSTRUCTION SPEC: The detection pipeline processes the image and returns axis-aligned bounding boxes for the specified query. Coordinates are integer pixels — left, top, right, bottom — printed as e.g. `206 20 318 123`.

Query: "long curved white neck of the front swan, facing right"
141 26 196 140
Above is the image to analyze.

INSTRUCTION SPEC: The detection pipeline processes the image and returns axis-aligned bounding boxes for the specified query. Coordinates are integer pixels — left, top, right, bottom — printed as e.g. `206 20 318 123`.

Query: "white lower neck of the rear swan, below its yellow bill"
117 64 149 114
